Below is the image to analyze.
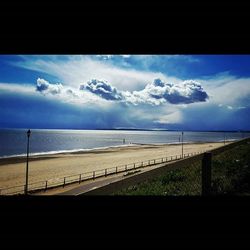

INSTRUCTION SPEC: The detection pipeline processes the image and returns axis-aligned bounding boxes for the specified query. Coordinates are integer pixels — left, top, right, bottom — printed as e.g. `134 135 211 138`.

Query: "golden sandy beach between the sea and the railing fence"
0 143 224 191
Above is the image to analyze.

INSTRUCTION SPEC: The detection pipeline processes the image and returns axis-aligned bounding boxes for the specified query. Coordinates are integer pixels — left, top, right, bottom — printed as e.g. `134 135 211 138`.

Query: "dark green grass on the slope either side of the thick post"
114 144 250 195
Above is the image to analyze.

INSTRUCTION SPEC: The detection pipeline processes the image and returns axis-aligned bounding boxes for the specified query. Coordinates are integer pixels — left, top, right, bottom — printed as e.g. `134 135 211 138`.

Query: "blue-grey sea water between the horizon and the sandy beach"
0 129 250 158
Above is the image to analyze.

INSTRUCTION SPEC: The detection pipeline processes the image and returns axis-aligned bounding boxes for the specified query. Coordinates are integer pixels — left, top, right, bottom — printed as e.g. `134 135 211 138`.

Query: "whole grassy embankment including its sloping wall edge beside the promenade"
84 138 250 195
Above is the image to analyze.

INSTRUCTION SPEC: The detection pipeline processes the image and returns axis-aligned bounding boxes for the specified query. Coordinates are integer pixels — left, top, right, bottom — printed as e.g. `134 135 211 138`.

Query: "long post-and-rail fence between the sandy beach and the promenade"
0 148 205 195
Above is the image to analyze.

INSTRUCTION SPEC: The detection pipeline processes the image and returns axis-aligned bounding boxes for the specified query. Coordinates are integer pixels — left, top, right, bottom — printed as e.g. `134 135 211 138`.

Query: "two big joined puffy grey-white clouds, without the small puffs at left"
80 79 208 105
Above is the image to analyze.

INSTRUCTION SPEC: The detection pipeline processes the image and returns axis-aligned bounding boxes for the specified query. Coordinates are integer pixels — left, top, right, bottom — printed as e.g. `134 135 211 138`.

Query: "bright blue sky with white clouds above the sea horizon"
0 55 250 131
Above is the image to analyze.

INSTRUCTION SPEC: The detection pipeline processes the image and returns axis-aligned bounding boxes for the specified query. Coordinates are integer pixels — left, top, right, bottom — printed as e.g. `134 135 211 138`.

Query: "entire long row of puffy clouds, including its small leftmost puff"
36 78 208 105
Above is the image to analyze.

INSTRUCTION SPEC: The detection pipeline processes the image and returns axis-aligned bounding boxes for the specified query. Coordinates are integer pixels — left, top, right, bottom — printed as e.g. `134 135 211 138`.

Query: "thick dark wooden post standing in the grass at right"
201 152 212 195
